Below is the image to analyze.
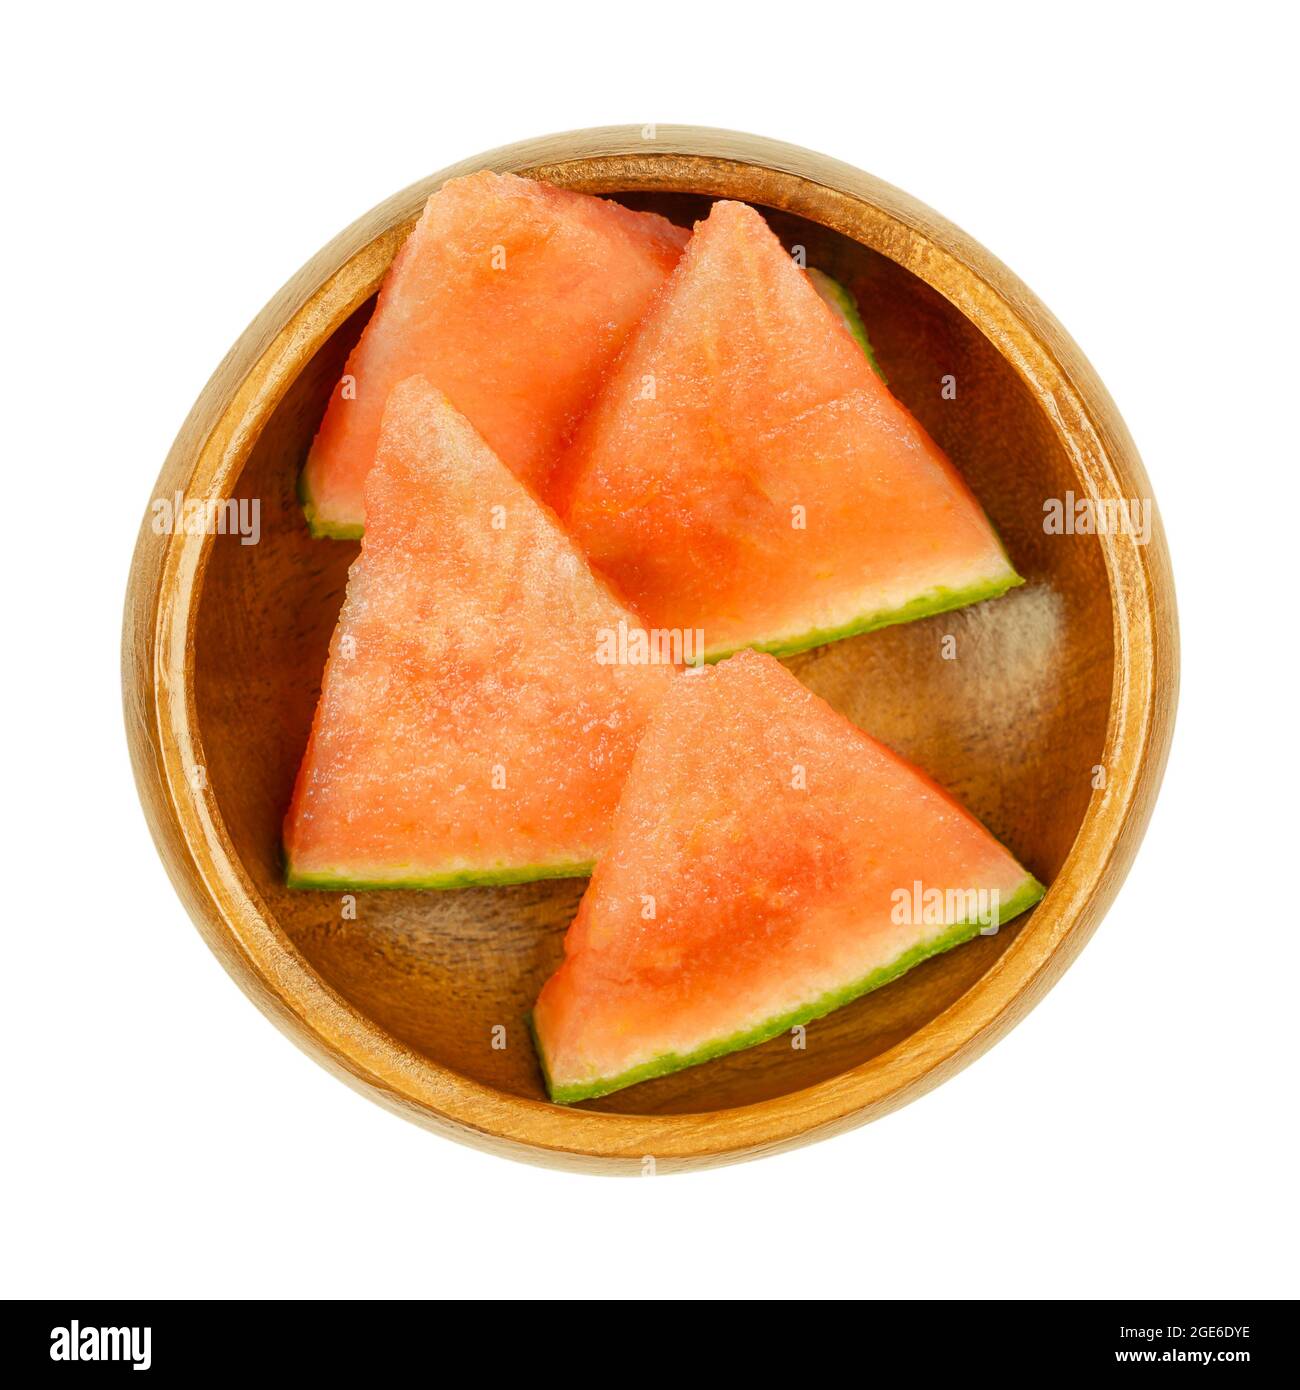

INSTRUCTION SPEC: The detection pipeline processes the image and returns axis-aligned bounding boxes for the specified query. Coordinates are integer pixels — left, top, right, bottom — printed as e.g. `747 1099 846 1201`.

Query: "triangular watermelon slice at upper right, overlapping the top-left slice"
551 202 1021 657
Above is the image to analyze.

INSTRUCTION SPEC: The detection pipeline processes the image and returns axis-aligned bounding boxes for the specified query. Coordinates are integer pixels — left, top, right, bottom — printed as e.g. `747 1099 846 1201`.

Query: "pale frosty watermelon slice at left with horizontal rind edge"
284 378 674 888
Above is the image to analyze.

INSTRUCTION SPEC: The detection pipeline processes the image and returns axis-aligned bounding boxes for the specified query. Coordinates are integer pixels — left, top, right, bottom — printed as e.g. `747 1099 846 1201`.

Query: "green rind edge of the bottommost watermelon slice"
528 874 1047 1105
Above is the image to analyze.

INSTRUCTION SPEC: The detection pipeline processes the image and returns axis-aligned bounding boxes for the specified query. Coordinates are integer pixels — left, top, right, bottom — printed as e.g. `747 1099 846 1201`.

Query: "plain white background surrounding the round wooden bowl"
0 0 1300 1298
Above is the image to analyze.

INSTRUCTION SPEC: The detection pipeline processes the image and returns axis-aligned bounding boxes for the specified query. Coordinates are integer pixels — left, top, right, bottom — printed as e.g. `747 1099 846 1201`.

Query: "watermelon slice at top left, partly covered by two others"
299 172 690 537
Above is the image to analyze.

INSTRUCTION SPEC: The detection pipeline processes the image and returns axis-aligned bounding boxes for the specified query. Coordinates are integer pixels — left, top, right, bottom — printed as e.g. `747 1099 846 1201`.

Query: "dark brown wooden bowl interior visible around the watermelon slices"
187 193 1112 1115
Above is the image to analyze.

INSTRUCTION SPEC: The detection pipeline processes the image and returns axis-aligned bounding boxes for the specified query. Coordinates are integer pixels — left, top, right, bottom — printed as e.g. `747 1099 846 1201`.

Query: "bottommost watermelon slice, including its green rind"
533 652 1043 1104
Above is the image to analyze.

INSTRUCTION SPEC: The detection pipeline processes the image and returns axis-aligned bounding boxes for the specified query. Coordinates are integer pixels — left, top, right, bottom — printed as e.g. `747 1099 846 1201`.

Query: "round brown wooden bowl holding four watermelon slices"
122 126 1178 1172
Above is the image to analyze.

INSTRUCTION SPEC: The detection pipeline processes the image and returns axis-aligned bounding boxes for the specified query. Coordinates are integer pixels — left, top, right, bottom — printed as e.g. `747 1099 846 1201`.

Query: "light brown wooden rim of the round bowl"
122 125 1178 1172
